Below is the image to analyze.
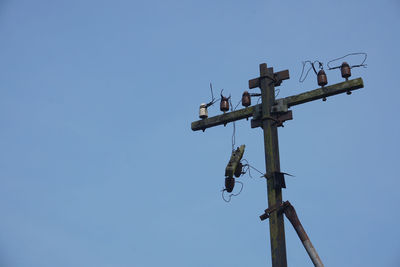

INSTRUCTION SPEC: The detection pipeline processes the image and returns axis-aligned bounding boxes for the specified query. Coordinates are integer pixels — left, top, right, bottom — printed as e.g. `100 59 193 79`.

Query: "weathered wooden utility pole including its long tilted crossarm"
191 63 364 267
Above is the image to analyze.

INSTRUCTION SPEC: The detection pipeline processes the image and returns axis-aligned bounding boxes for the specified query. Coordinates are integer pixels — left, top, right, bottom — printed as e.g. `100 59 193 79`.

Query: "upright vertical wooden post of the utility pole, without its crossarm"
259 63 287 267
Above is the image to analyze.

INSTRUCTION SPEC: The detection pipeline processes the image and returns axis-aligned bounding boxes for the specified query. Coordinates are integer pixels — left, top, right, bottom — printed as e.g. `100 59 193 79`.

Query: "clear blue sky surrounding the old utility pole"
0 0 400 267
